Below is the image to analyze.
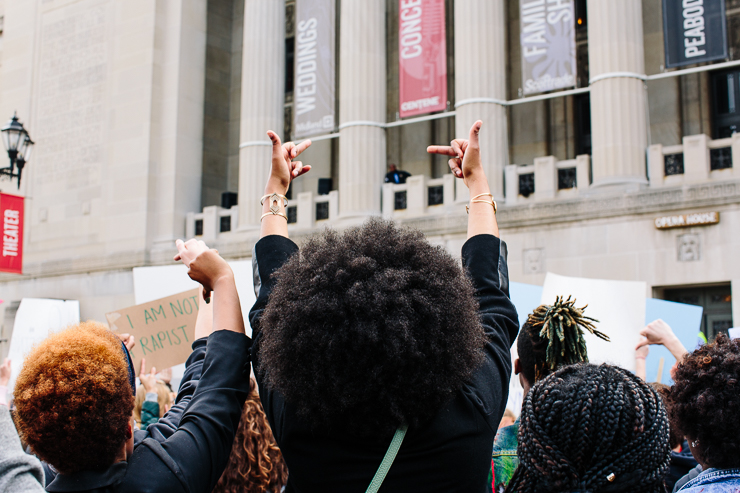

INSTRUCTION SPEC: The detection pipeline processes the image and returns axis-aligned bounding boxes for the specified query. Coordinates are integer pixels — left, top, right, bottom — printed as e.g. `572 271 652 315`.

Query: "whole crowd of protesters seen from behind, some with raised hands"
0 121 740 493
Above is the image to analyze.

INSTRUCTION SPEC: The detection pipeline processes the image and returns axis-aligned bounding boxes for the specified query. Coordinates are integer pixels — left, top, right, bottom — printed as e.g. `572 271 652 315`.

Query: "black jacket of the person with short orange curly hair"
45 330 250 493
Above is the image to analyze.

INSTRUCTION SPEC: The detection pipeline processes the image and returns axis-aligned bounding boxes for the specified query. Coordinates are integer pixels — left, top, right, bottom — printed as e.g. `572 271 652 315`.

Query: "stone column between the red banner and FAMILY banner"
455 0 509 200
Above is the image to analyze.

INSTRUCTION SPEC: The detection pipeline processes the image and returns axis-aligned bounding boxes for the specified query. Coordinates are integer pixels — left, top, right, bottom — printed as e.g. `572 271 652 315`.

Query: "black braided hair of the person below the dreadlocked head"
506 363 671 493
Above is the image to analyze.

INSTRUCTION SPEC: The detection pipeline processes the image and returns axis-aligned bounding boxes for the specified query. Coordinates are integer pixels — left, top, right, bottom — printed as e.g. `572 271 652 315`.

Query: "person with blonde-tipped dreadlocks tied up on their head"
488 296 609 493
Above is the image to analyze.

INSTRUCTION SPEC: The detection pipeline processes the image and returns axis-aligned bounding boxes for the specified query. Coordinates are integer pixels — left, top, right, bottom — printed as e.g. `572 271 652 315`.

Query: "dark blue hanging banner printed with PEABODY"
663 0 727 68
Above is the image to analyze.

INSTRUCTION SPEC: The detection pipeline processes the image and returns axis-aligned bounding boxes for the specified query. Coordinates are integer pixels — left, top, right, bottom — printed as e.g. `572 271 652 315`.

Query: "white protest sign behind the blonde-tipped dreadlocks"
540 273 647 372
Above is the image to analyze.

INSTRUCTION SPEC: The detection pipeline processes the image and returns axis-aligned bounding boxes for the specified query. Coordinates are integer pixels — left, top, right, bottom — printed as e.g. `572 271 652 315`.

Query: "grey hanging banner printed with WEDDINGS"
293 0 335 138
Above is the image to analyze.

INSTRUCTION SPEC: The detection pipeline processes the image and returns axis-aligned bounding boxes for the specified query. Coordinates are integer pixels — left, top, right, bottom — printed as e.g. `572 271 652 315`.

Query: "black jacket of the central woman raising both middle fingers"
250 235 518 493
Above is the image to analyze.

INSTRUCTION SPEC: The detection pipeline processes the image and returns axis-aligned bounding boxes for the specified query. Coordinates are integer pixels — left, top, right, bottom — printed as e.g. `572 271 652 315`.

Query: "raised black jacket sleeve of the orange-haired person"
122 330 250 492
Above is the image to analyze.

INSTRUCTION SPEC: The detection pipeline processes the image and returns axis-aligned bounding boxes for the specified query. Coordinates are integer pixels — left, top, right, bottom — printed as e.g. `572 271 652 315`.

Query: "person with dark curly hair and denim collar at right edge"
666 334 740 493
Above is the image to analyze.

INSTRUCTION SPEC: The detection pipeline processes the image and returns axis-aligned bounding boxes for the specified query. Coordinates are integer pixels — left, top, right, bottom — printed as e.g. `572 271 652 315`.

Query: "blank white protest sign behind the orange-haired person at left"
8 298 80 393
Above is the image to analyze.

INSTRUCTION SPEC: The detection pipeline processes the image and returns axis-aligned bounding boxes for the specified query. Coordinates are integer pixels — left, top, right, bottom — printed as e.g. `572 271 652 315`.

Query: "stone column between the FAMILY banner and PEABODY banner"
588 0 647 188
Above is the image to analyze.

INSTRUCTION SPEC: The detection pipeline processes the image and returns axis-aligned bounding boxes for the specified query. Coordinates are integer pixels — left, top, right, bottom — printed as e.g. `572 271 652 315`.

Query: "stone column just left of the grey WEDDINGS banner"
238 0 285 229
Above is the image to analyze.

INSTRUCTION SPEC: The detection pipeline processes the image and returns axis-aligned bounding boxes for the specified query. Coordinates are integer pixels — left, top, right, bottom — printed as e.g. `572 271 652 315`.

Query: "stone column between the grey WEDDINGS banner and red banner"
339 0 386 217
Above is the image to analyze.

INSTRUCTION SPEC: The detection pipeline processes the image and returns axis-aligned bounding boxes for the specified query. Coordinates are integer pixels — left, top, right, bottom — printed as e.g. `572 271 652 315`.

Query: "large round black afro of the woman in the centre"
260 219 485 440
